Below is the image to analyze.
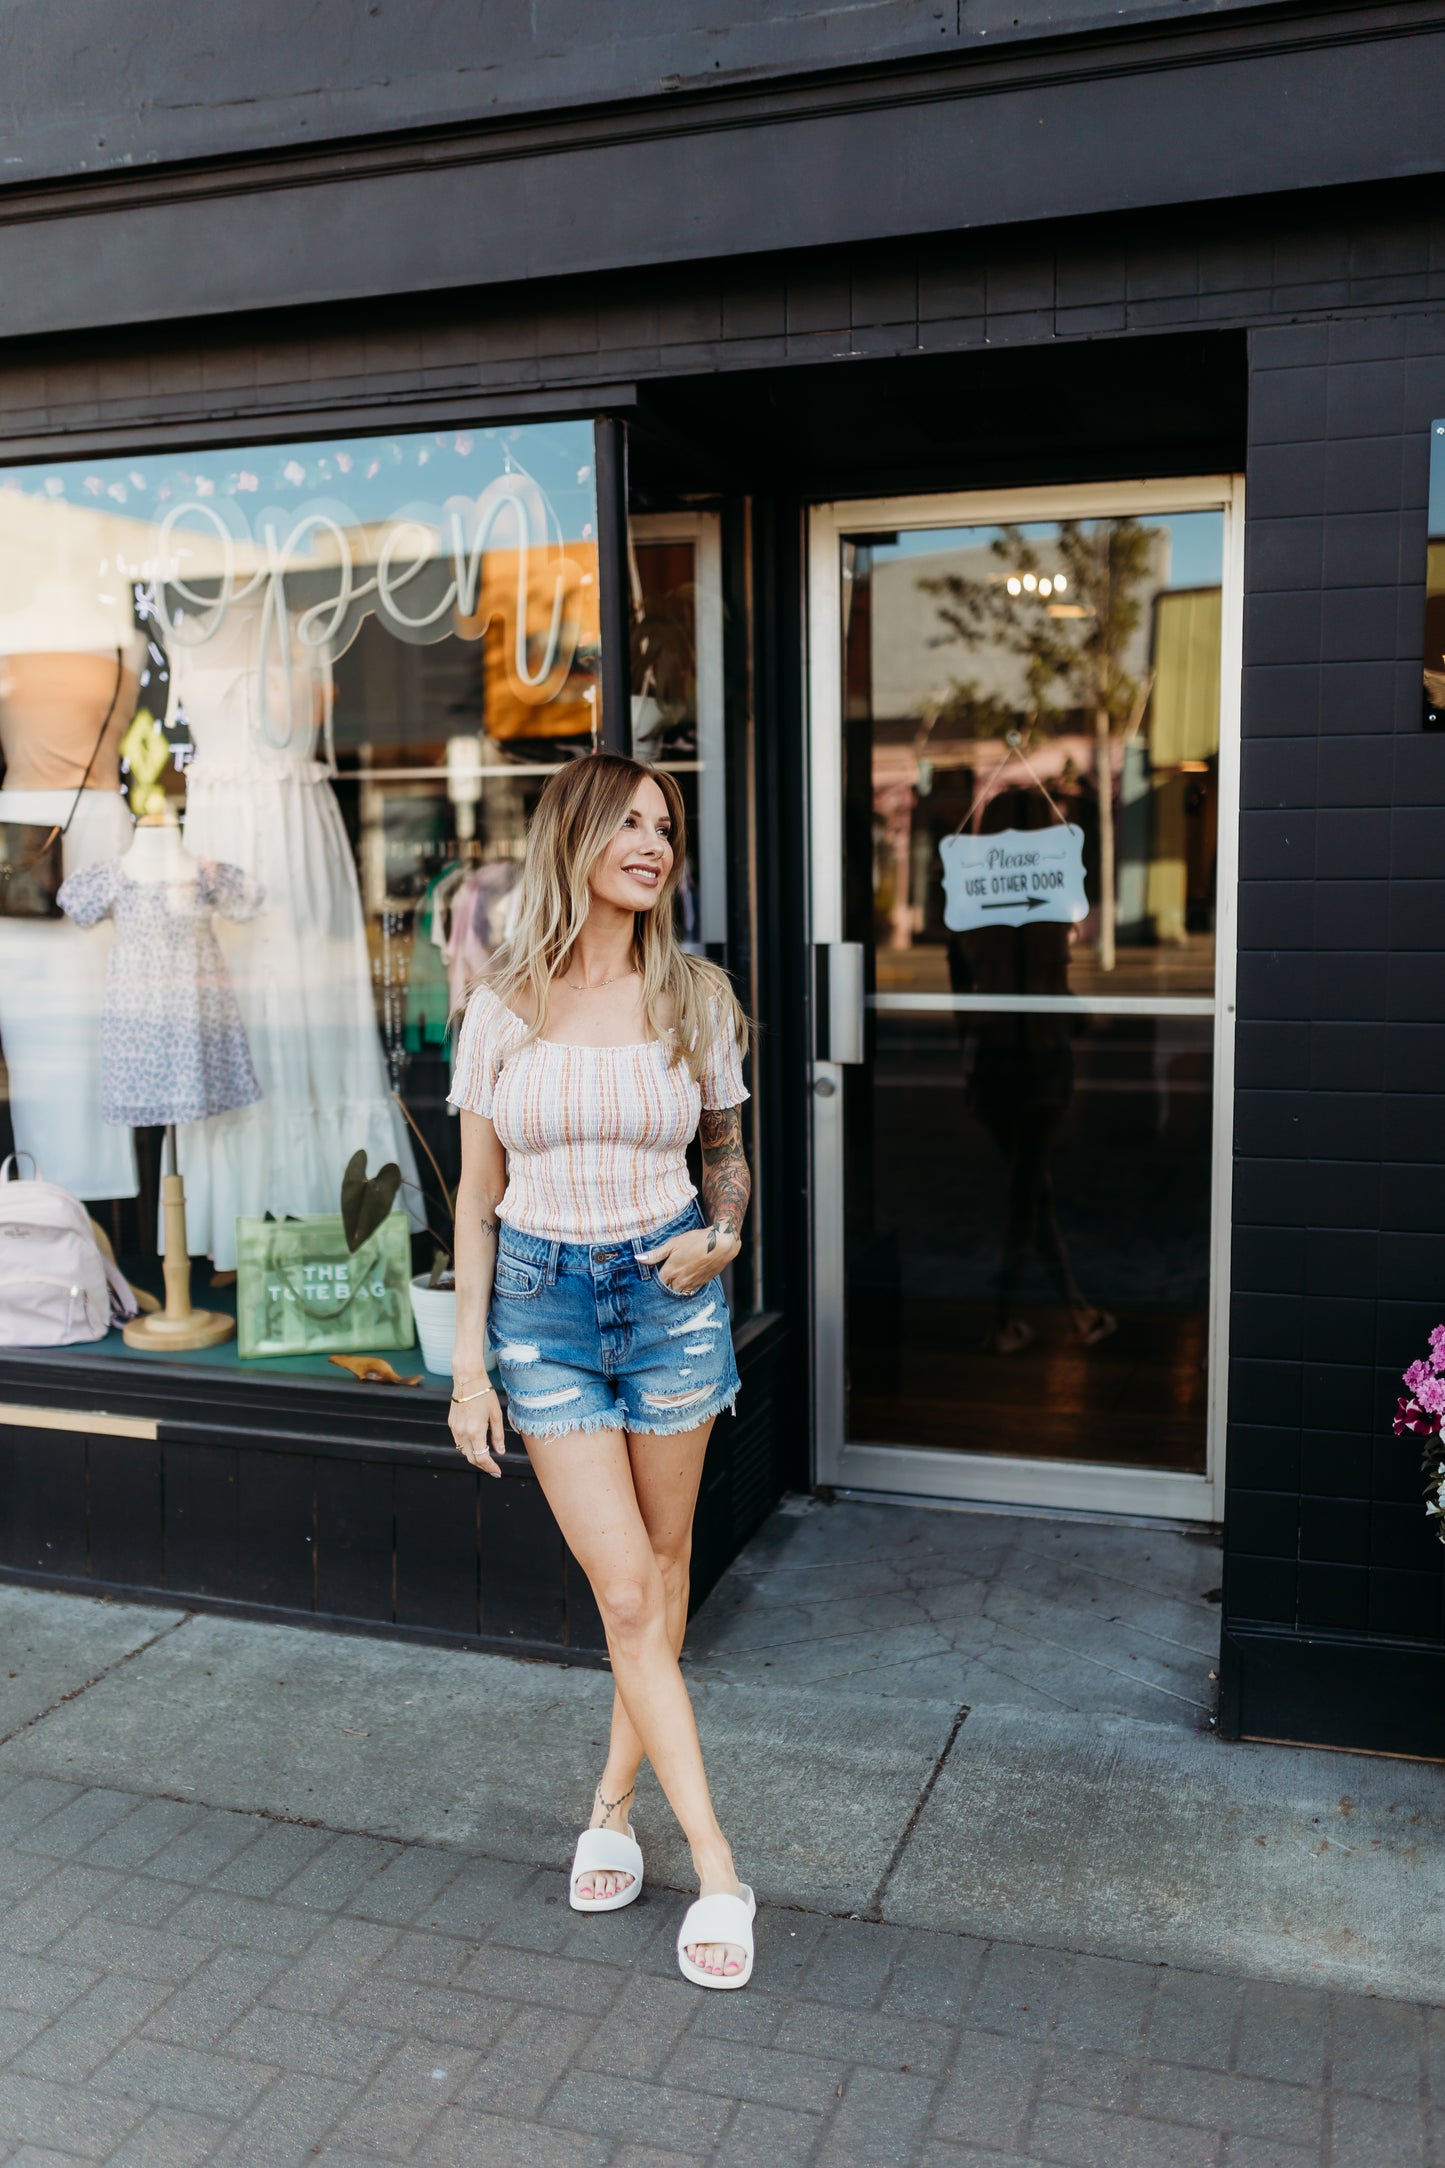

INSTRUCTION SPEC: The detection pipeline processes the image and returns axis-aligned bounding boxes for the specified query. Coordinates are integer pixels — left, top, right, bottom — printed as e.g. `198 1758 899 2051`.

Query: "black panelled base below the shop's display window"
0 1309 786 1665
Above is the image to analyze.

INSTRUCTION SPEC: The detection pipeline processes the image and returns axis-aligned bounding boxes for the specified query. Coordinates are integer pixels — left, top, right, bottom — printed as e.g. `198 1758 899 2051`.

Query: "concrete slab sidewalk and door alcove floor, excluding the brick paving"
0 1505 1445 1999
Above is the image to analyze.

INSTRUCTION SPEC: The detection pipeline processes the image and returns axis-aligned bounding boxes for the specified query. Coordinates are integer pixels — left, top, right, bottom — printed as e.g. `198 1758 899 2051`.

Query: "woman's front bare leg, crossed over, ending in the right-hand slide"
524 1431 743 1971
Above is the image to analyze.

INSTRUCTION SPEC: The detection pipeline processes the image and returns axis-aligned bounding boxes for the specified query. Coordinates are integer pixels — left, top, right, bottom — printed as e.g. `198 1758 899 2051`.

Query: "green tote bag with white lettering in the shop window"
236 1212 414 1357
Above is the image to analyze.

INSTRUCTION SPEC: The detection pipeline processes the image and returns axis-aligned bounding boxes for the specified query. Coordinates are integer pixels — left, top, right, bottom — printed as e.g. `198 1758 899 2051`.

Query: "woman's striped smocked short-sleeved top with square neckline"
448 986 747 1242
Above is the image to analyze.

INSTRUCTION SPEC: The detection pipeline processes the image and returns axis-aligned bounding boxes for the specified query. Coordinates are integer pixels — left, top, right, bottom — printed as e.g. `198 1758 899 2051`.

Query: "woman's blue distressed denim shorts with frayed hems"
487 1203 739 1437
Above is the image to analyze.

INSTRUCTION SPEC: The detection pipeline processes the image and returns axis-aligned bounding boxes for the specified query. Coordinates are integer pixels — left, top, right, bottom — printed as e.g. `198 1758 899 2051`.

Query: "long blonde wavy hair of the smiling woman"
485 752 750 1080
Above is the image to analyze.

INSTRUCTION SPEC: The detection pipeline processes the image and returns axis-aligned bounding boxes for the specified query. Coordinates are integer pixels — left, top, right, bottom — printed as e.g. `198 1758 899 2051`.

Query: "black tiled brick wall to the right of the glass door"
1226 310 1445 1641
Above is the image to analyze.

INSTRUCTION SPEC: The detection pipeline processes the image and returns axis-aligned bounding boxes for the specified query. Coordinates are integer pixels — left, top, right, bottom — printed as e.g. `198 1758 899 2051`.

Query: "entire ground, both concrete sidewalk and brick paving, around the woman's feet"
0 1505 1445 2168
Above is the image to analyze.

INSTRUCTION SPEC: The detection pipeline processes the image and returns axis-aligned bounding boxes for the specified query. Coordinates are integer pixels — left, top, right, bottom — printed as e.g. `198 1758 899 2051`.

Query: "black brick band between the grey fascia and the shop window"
0 184 1445 446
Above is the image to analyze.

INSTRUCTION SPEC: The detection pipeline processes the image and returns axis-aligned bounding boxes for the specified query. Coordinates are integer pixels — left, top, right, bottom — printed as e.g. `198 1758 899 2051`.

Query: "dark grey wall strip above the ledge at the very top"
0 0 1267 180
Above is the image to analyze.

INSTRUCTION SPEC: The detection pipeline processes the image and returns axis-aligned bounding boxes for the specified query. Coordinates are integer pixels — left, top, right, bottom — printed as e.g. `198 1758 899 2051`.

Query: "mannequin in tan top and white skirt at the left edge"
0 633 145 1199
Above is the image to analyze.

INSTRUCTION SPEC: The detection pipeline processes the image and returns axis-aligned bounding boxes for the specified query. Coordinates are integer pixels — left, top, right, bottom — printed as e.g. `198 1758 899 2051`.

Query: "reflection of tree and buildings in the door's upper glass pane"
843 514 1222 992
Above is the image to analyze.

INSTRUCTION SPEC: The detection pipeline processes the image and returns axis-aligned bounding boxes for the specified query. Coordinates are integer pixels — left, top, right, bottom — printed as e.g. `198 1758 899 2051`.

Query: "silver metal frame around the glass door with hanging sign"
806 475 1244 1522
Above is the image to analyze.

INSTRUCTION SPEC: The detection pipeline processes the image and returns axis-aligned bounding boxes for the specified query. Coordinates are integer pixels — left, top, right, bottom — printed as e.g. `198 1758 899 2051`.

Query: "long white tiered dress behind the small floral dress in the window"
169 603 416 1270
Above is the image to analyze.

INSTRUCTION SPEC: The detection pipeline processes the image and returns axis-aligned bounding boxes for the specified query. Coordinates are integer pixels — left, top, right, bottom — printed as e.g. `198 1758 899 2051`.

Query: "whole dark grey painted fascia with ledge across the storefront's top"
0 0 1445 340
